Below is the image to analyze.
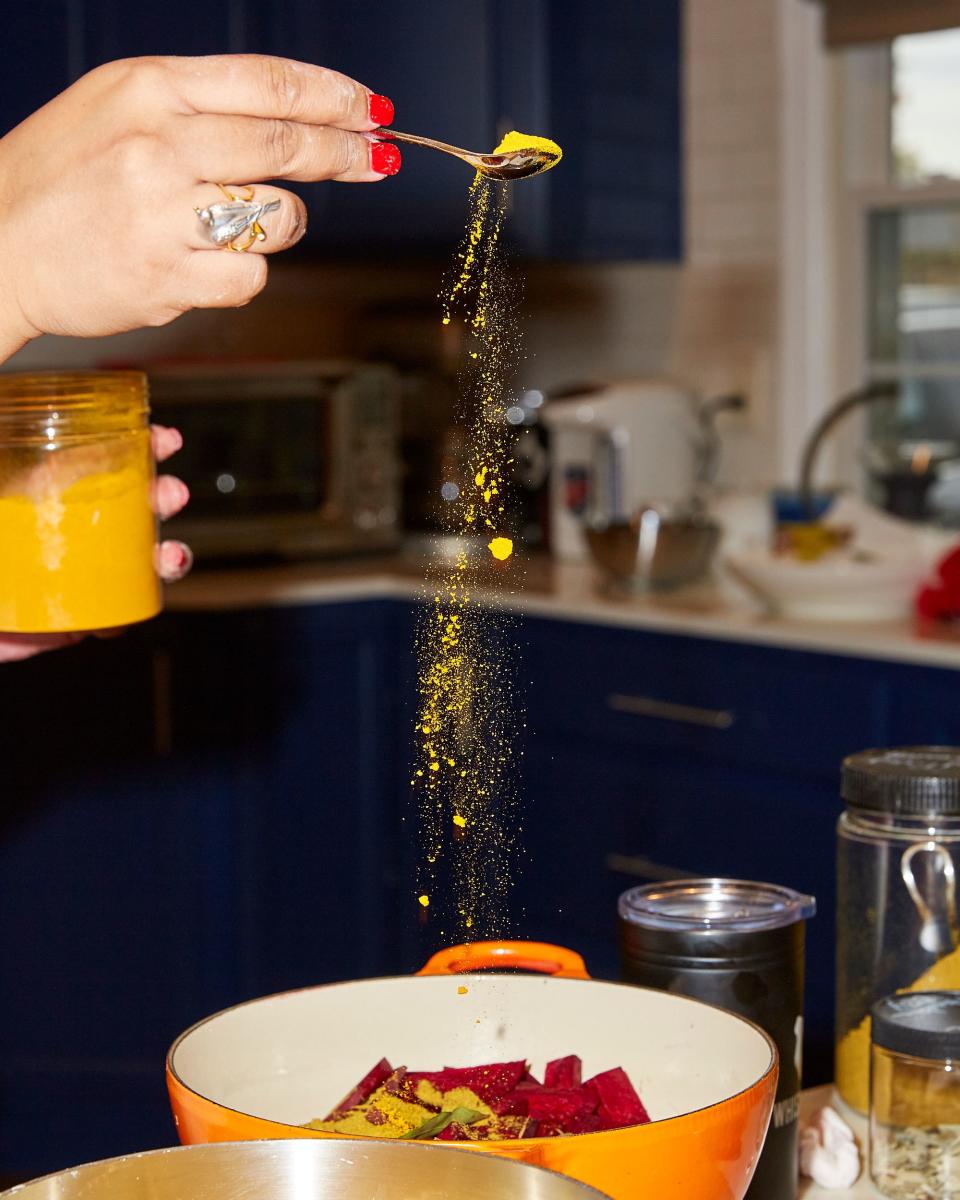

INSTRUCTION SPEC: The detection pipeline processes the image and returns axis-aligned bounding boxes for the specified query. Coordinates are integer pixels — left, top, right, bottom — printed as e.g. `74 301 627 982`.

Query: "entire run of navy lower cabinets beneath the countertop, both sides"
0 590 960 1177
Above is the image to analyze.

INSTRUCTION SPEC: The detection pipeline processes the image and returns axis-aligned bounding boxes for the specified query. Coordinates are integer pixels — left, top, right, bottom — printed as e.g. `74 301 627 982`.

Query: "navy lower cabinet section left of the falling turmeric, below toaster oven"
0 601 400 1177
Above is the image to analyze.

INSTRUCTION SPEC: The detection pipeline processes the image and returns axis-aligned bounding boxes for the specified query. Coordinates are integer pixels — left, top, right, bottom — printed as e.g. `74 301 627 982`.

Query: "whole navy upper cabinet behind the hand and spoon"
0 0 683 262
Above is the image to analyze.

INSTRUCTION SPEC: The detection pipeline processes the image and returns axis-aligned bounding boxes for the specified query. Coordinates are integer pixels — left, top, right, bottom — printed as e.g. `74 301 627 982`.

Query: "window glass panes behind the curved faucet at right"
839 29 960 524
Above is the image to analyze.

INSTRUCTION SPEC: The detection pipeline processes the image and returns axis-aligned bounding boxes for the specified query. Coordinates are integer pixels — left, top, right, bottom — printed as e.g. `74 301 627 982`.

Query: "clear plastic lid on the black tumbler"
619 878 817 934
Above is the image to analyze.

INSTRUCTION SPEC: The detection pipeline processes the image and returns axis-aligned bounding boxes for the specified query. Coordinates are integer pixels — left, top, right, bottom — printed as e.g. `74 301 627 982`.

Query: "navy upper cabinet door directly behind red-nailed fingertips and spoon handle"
251 0 494 257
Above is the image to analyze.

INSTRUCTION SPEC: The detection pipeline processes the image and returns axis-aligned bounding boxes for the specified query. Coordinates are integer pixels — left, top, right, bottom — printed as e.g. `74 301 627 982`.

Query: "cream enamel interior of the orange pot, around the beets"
170 974 774 1124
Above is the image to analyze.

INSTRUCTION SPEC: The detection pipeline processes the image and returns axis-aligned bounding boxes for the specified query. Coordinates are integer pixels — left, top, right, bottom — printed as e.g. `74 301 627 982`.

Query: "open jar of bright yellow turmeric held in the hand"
0 371 161 634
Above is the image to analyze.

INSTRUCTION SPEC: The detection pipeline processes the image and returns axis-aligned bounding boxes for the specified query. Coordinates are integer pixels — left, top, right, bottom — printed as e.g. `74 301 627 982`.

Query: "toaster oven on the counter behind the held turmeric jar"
146 361 400 558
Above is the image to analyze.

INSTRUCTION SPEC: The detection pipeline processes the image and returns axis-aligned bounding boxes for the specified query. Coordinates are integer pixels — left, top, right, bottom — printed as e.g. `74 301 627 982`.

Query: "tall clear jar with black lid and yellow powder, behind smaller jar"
835 746 960 1115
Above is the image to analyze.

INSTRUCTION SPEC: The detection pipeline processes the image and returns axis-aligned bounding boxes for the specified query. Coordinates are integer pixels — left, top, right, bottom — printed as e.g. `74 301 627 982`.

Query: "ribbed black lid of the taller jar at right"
840 746 960 816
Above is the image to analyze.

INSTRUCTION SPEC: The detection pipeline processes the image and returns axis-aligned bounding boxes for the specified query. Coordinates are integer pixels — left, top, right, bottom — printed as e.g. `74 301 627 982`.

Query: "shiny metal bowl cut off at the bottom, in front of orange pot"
0 1140 612 1200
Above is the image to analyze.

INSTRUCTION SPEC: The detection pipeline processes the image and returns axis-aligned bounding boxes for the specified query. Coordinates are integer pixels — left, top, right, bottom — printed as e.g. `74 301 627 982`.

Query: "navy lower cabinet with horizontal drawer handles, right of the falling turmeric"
514 618 960 1084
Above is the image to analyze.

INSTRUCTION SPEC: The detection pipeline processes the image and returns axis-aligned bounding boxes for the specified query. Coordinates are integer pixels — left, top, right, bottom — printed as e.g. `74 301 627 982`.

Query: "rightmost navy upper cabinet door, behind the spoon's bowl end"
496 0 683 262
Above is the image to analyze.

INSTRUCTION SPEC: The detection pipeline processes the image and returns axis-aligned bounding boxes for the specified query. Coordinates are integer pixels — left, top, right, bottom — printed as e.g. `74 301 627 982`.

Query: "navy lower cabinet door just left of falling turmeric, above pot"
210 602 400 996
